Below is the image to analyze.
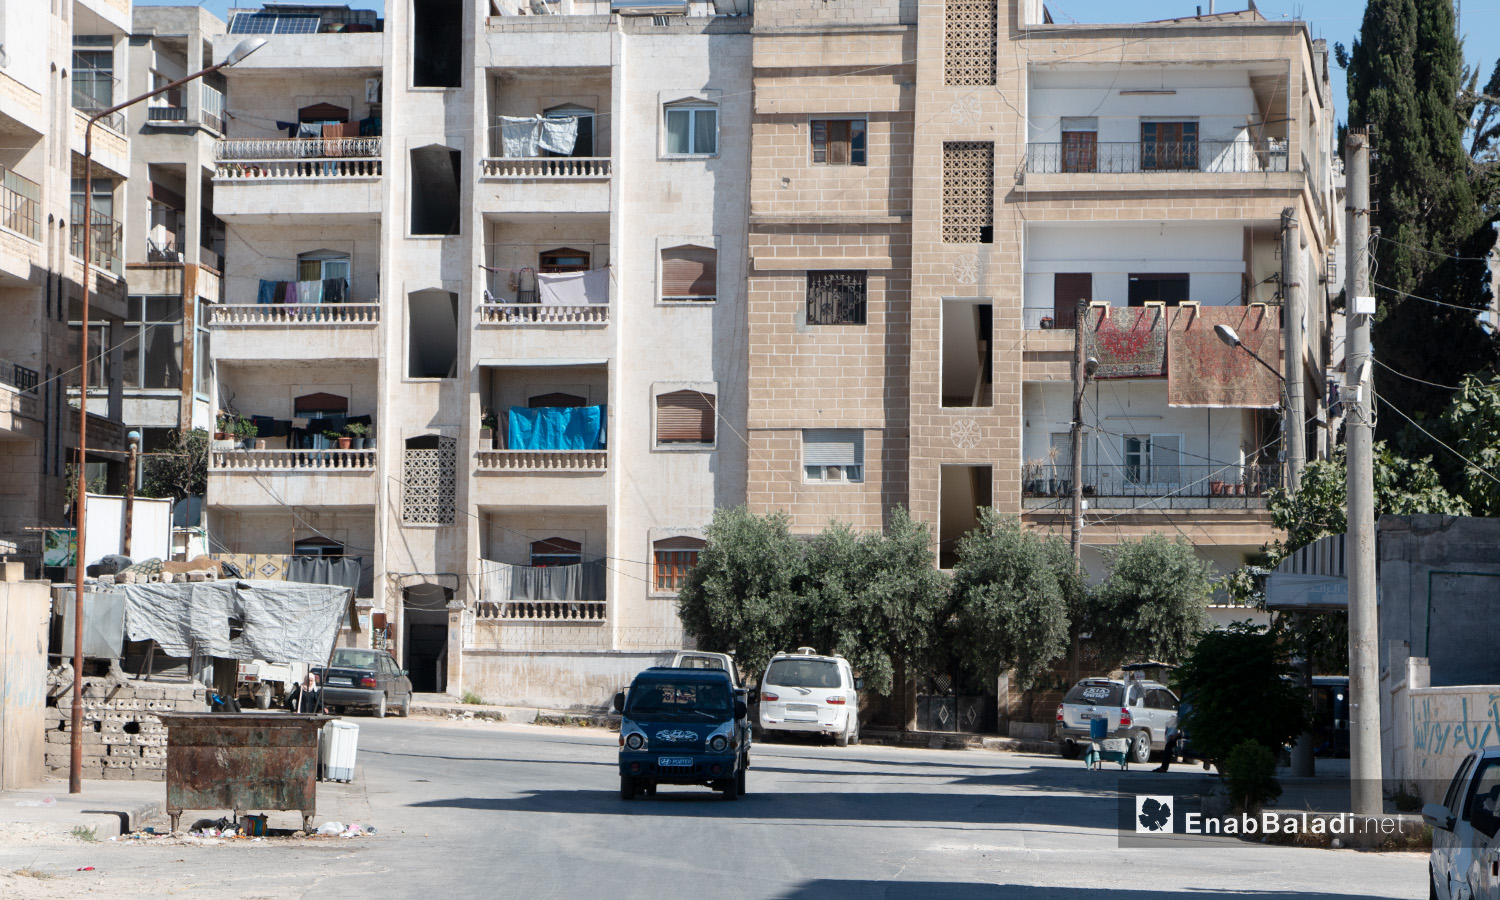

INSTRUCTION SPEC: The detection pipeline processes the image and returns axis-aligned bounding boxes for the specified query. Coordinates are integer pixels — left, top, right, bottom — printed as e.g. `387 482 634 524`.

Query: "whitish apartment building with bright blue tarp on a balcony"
203 0 750 705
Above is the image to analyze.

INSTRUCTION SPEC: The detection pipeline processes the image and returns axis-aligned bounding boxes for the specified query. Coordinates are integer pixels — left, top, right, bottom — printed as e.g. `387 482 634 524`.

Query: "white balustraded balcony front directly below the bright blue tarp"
473 449 609 507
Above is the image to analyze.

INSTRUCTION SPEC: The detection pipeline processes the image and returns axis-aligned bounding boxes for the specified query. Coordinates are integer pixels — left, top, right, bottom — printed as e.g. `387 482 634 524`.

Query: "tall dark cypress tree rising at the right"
1338 0 1500 438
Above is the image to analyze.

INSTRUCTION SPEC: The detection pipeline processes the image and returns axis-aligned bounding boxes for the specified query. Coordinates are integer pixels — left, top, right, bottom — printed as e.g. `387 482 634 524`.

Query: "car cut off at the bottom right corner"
1422 747 1500 900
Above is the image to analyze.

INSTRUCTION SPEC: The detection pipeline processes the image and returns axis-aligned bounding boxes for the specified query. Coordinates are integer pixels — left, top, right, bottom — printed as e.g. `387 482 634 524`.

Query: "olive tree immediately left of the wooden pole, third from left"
953 509 1071 693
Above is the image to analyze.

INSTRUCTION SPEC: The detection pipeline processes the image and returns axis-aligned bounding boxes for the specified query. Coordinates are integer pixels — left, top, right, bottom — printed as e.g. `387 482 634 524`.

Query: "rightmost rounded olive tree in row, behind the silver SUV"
1092 534 1215 663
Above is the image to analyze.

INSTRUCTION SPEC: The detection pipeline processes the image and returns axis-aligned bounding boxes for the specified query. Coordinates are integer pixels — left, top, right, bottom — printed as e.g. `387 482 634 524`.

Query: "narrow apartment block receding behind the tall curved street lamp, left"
120 6 225 453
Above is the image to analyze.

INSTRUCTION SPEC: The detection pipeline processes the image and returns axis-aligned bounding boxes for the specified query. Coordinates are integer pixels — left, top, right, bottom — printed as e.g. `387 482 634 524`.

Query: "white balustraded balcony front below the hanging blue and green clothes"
207 303 380 362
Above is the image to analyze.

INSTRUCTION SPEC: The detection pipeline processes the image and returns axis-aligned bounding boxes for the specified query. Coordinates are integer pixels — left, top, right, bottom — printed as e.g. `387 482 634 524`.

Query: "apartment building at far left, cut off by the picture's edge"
0 0 131 564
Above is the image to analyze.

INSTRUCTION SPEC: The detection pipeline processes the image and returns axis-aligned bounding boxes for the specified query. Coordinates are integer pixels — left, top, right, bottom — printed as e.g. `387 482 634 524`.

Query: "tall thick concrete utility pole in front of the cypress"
1344 129 1383 816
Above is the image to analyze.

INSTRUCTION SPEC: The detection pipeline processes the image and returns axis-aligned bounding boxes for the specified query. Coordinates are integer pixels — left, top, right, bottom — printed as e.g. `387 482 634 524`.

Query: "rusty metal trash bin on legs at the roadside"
158 713 330 831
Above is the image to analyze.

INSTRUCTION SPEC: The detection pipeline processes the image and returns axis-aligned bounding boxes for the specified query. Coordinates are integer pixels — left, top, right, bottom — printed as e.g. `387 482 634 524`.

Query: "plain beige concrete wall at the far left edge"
0 582 51 791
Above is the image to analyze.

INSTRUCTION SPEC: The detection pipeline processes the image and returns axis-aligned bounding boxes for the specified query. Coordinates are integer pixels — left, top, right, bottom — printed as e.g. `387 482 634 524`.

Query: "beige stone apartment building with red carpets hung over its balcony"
749 0 1340 573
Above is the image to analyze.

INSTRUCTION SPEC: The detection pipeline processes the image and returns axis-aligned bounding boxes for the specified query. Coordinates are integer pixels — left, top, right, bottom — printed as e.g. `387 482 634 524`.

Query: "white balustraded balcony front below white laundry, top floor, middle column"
474 156 612 213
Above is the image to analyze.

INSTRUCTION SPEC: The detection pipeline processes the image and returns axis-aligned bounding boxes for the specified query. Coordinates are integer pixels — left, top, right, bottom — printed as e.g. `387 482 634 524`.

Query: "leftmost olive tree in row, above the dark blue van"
677 507 806 672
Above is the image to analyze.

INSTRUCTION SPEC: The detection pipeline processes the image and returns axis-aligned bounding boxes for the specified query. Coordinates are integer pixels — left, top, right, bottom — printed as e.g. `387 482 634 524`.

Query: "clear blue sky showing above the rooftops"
135 0 1500 120
